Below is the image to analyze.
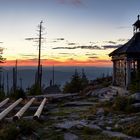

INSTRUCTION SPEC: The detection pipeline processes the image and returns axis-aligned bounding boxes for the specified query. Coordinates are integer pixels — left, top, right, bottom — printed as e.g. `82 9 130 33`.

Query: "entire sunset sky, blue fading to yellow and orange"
0 0 140 66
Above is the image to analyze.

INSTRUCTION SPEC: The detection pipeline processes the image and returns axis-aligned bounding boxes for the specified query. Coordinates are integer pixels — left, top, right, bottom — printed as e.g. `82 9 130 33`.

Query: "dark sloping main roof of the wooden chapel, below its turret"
109 32 140 56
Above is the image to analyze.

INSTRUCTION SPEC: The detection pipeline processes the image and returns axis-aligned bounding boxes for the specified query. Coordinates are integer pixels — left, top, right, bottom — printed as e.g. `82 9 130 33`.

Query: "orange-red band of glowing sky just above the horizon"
0 59 112 67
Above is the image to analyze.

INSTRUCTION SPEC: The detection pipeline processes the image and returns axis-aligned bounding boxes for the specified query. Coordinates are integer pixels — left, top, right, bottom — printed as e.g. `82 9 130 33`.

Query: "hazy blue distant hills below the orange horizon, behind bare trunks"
3 67 112 89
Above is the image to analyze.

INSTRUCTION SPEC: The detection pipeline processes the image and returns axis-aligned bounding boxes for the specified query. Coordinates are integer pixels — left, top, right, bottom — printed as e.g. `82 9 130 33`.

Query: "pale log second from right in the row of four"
13 98 35 120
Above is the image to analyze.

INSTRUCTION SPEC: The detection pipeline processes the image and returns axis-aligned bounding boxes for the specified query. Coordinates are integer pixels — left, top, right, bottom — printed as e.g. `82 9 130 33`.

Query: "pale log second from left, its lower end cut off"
0 98 23 120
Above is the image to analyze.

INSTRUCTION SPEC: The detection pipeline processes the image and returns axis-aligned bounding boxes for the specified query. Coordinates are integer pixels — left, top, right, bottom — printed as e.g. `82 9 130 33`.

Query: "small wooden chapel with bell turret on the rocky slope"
109 15 140 89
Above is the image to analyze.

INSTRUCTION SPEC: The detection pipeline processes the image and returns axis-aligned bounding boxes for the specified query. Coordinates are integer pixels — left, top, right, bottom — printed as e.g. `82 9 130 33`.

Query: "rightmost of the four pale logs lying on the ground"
33 98 47 120
